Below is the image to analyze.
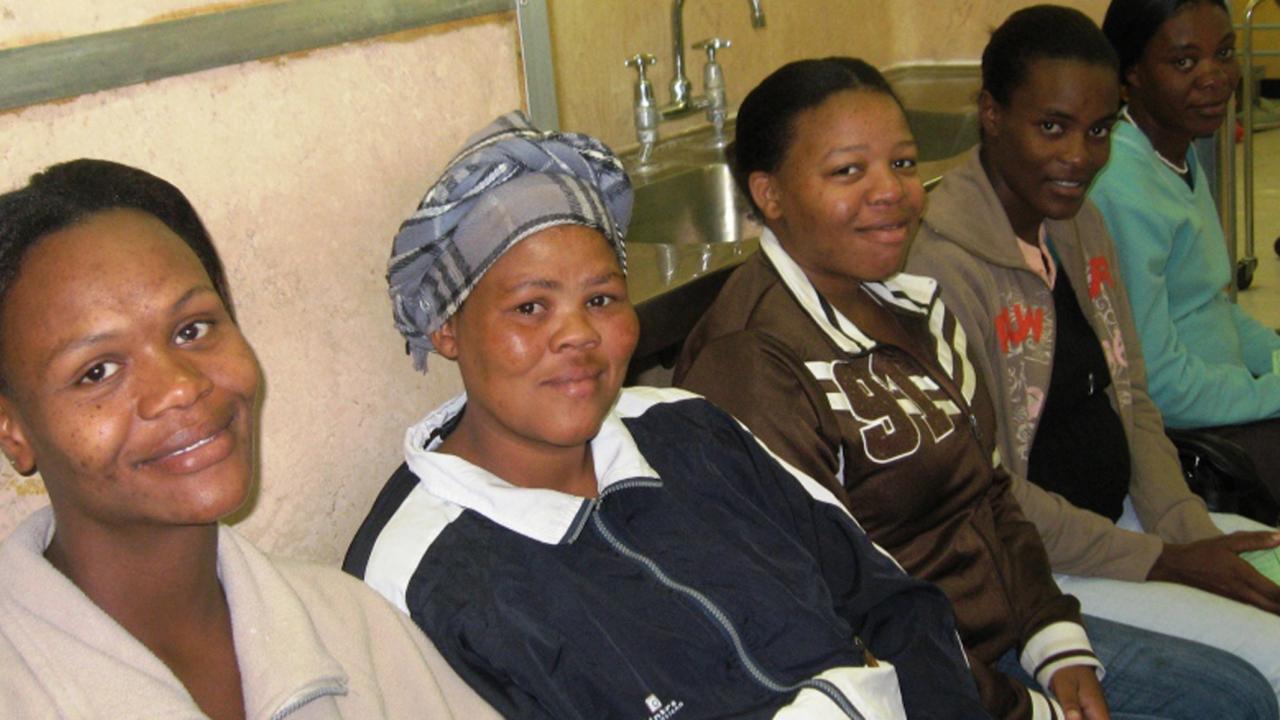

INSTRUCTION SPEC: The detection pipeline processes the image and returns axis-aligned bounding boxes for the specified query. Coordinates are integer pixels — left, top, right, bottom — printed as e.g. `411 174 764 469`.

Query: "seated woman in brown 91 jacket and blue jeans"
676 58 1275 717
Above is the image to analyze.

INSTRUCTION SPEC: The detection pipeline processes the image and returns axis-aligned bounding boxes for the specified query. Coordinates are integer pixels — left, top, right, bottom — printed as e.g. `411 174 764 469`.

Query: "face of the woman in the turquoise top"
1125 3 1240 160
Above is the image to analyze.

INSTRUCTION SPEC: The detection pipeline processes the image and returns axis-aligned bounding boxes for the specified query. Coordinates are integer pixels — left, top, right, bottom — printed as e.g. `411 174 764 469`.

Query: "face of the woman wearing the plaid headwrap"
431 225 640 452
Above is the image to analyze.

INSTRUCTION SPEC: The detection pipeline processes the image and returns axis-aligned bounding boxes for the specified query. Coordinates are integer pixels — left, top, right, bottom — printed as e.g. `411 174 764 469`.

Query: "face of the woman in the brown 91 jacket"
749 90 924 288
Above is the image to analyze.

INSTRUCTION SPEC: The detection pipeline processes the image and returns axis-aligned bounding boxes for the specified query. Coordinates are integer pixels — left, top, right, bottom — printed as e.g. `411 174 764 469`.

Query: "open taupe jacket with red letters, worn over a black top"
908 149 1221 580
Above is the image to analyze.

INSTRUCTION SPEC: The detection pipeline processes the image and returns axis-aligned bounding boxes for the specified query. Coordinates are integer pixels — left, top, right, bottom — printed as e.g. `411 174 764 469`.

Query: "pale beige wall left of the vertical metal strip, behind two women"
0 8 521 561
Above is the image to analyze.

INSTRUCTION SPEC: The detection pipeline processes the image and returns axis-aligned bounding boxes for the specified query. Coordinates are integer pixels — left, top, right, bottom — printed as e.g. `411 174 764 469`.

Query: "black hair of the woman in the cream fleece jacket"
0 159 233 389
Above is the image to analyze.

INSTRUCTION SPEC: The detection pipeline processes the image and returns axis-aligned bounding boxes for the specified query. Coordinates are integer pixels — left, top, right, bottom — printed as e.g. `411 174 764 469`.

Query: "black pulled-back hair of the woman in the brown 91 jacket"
728 56 902 215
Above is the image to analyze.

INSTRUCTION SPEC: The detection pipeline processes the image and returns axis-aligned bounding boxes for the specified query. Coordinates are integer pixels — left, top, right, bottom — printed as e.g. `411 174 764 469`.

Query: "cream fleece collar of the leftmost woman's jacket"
0 506 347 717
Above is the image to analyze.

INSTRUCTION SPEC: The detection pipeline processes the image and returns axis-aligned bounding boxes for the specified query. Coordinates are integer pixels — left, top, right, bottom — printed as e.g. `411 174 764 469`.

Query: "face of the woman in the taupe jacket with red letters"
978 58 1120 238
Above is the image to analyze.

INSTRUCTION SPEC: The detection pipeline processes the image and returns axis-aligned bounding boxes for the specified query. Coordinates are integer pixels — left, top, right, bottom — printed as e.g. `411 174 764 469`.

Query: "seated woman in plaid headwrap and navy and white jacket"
344 113 987 720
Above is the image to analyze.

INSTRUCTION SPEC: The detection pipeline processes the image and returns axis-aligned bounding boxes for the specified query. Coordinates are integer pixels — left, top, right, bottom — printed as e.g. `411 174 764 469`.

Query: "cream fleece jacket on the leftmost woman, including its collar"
0 507 498 720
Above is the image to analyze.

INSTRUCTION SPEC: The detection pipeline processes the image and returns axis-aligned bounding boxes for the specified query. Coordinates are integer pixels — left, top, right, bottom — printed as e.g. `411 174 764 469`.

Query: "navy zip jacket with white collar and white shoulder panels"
344 388 988 720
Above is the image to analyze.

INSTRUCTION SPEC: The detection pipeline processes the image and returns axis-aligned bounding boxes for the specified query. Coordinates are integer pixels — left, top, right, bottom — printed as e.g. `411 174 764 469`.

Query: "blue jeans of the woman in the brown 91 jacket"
996 615 1280 720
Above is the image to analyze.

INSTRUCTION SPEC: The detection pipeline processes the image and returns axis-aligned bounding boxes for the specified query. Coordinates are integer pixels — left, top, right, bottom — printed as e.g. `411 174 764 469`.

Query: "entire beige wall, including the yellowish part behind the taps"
0 0 1121 561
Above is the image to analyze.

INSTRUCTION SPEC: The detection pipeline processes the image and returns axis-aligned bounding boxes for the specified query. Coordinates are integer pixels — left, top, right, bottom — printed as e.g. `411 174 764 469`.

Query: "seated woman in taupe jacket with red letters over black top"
908 5 1280 688
